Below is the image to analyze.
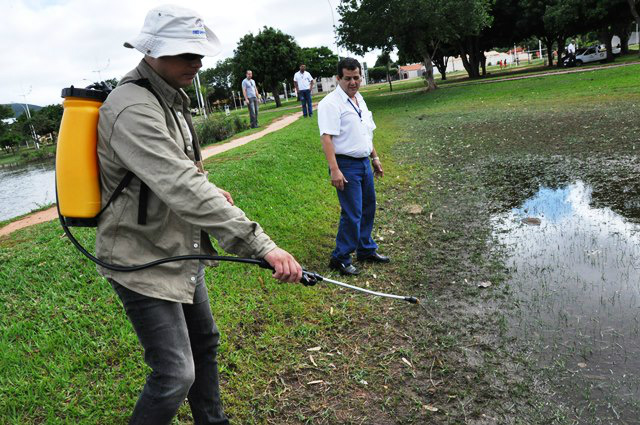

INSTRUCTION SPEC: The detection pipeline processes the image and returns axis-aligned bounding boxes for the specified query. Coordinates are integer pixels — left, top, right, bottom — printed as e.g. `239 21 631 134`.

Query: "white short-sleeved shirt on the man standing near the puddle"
318 85 376 158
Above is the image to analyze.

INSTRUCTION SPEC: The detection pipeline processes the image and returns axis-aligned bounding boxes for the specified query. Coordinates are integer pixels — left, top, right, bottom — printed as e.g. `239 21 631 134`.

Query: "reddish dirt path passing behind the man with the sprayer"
0 111 304 237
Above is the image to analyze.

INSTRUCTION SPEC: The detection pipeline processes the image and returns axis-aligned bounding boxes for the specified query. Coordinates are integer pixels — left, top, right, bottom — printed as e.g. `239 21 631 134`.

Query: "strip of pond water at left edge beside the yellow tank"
0 161 56 221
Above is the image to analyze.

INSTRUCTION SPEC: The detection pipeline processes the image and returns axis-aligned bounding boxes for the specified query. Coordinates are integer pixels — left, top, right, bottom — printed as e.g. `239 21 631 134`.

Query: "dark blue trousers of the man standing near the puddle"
331 157 378 264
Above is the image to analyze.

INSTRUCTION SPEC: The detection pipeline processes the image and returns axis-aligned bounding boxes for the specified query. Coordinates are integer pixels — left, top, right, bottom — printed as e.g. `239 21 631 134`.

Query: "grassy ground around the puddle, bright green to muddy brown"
0 61 640 425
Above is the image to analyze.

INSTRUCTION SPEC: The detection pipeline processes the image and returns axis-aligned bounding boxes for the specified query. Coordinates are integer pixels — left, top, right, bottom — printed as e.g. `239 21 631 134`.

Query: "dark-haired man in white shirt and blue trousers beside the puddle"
318 58 390 275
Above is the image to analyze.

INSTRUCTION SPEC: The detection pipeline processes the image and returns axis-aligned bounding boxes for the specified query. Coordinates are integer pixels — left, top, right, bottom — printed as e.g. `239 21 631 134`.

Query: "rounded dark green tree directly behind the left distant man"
234 27 300 107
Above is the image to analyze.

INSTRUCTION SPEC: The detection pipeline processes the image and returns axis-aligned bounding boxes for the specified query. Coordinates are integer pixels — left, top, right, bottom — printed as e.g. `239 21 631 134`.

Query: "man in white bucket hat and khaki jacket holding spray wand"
96 5 302 425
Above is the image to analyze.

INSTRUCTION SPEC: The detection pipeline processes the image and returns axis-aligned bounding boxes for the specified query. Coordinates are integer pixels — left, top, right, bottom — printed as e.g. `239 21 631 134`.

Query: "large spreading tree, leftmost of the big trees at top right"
338 0 493 85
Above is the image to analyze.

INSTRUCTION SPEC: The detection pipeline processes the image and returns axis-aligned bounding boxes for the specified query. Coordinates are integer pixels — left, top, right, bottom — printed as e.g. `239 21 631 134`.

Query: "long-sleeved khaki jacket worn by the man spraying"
96 60 276 303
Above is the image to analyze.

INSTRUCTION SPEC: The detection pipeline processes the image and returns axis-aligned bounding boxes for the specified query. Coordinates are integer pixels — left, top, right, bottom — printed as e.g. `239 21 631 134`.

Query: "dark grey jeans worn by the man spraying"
110 265 229 425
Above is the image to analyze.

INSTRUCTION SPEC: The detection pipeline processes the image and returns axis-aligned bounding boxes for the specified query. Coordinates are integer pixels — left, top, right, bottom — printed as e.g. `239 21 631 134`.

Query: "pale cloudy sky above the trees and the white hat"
0 0 376 105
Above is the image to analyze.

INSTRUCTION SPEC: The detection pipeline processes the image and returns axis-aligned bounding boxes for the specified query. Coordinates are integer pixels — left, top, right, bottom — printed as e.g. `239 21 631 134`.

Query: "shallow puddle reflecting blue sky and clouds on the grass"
492 181 640 424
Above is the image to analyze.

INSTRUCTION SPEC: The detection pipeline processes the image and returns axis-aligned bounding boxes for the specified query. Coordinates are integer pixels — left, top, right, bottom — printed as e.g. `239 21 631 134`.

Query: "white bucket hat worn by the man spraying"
124 4 221 58
